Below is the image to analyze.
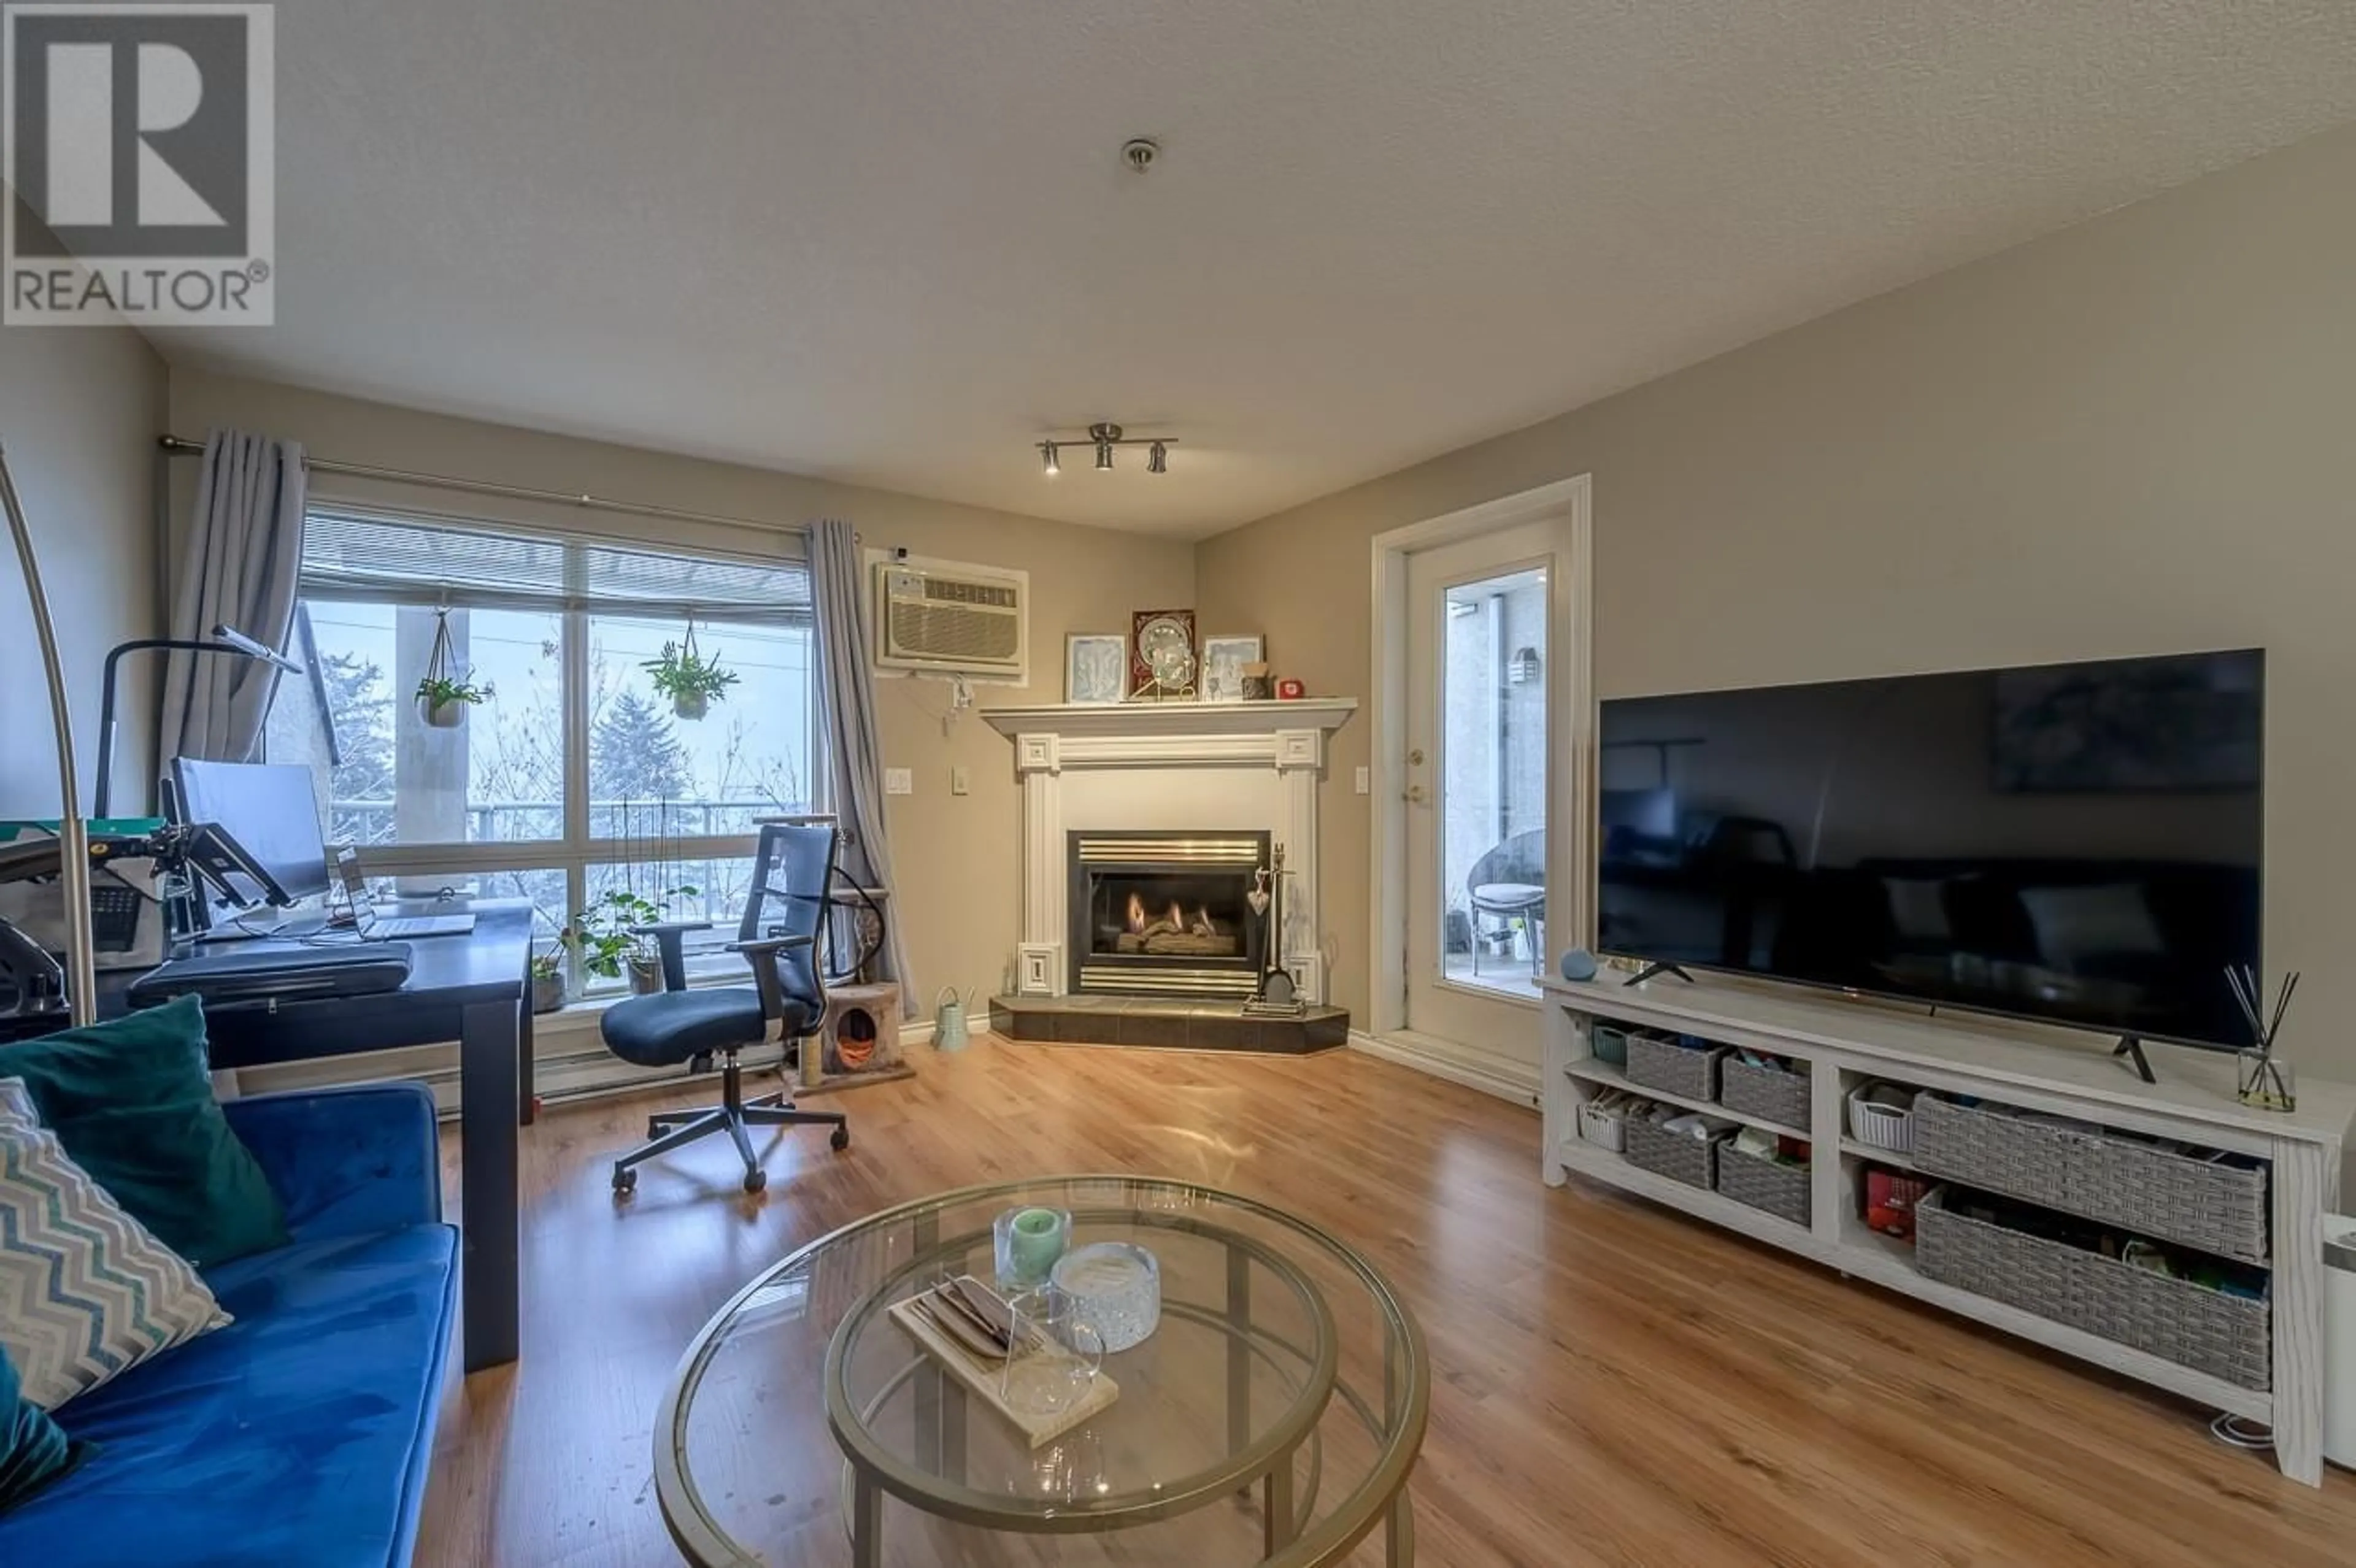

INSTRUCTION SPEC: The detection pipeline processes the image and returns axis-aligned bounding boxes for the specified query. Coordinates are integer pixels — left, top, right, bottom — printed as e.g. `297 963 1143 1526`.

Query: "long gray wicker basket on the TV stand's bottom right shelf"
1915 1186 2274 1389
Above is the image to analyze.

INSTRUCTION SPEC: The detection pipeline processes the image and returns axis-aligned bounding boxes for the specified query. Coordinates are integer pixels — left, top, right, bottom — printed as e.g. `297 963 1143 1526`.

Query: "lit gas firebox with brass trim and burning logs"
1068 831 1270 1001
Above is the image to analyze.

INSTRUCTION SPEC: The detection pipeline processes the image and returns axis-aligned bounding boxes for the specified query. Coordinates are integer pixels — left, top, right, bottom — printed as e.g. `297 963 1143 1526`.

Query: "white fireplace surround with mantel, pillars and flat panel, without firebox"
982 697 1357 1003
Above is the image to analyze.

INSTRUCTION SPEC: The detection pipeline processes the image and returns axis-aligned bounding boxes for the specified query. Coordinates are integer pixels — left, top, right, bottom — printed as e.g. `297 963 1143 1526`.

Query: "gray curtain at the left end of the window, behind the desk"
155 431 304 763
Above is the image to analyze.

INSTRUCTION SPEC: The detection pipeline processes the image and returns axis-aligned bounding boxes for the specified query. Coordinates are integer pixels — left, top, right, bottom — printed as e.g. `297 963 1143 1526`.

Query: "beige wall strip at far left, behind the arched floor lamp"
0 310 165 817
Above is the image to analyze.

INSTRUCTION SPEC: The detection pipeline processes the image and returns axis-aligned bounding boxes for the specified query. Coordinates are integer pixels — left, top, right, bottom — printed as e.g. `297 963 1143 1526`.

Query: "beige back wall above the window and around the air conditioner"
172 370 1195 998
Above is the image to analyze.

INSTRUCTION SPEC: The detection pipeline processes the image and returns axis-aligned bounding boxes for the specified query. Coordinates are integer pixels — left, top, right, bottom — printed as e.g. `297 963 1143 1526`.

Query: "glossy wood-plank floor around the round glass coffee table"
417 1038 2356 1568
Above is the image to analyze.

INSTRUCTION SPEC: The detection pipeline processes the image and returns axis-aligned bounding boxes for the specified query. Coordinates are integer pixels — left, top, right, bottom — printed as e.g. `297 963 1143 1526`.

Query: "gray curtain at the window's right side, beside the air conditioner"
810 520 921 1017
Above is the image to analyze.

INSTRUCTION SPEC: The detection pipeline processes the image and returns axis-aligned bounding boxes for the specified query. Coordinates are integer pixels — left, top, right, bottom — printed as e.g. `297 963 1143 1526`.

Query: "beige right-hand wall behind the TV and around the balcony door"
1197 127 2356 1078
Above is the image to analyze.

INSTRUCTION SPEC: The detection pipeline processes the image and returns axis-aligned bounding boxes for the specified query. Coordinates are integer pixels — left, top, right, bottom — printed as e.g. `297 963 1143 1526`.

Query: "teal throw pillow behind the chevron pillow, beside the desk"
0 996 290 1269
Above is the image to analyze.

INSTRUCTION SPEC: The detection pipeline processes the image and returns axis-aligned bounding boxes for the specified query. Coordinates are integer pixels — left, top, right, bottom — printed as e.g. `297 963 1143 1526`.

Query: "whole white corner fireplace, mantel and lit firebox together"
982 699 1357 1021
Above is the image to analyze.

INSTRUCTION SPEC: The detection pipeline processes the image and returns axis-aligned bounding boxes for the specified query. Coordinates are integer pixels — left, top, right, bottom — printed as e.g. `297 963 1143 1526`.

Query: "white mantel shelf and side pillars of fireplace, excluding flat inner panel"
982 697 1357 1003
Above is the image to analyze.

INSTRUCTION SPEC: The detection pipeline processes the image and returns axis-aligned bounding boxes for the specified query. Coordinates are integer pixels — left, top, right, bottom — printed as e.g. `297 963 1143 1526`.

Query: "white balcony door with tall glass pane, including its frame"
1371 480 1593 1095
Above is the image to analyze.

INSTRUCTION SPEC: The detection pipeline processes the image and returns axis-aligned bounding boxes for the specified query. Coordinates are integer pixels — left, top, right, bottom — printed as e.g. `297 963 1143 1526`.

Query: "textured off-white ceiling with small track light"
163 0 2356 534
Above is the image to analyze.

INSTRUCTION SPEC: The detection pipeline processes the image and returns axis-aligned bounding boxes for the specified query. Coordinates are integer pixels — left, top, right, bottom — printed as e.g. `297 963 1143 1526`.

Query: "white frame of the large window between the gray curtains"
294 501 834 996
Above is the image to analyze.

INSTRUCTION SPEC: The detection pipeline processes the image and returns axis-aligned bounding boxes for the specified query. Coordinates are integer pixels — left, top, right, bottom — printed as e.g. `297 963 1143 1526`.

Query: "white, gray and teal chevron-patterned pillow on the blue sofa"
0 1078 228 1410
